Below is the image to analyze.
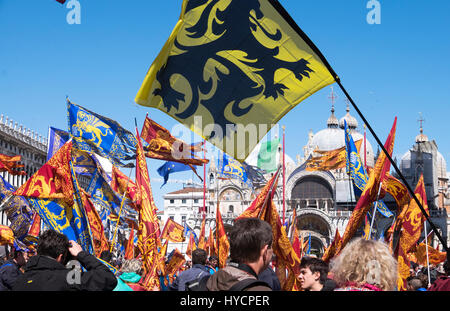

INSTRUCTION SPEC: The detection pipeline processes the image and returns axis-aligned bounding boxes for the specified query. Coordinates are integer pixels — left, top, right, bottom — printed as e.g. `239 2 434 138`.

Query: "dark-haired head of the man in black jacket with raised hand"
37 230 71 263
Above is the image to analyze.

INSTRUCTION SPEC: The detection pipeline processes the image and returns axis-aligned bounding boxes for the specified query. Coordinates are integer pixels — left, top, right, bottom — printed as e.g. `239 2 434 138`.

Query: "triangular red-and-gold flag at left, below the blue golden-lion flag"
14 140 74 205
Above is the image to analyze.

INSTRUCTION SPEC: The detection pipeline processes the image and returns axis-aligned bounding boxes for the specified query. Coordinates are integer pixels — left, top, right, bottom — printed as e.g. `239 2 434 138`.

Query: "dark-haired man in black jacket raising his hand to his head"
13 230 117 291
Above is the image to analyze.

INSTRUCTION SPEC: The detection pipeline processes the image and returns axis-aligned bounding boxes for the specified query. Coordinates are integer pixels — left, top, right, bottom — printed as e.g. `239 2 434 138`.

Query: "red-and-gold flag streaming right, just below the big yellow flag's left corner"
141 116 209 170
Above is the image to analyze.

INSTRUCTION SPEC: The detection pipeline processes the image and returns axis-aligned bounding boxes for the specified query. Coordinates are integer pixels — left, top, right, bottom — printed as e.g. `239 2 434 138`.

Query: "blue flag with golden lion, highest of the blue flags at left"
67 101 137 166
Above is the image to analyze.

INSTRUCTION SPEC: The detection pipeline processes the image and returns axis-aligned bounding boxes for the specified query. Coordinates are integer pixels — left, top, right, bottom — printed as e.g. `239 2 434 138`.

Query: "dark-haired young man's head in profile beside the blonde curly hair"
299 257 329 290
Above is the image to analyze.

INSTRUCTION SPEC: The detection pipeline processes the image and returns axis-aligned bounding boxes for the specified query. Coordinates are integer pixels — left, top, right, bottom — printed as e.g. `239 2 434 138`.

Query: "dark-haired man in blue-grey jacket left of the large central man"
171 248 210 291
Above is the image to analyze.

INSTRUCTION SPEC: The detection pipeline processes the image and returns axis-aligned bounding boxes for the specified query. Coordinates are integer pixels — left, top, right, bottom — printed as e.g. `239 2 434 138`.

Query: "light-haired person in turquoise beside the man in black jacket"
114 259 145 291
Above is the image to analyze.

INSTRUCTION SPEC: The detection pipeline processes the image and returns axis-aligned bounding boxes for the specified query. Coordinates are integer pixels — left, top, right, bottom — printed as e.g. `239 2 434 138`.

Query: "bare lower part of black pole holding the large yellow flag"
336 80 449 253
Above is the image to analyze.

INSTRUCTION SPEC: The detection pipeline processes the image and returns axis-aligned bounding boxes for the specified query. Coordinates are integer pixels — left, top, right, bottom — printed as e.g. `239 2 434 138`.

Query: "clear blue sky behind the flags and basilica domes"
0 0 450 209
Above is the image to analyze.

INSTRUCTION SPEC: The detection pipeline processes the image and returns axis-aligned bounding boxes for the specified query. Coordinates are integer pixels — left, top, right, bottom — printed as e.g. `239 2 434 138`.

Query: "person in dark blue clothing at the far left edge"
0 244 28 291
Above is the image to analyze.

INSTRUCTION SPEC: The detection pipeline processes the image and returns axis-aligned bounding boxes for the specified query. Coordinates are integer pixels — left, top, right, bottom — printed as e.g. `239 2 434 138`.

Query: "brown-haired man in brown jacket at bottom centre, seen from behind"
206 218 273 291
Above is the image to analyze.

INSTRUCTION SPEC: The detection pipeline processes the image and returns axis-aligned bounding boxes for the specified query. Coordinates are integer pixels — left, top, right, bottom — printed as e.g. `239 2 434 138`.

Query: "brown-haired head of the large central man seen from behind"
229 218 273 273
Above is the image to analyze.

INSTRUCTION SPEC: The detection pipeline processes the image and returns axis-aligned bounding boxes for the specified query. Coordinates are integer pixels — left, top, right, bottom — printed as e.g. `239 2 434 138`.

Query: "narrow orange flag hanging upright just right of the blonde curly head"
394 174 428 291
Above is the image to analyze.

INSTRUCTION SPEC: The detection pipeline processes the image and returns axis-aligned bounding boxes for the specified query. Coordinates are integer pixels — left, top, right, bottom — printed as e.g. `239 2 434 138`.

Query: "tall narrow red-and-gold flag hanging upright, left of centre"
136 129 161 291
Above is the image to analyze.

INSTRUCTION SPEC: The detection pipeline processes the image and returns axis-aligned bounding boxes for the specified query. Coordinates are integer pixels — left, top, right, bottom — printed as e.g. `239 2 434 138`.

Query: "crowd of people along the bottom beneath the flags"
0 218 450 291
